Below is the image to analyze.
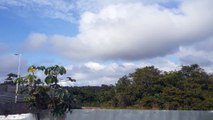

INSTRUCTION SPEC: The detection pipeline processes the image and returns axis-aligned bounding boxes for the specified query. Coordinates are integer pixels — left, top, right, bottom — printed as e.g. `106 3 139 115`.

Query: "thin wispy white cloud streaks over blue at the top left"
0 0 75 22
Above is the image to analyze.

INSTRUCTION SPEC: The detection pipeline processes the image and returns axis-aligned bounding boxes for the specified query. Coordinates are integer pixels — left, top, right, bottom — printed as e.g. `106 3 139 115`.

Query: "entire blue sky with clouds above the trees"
0 0 213 86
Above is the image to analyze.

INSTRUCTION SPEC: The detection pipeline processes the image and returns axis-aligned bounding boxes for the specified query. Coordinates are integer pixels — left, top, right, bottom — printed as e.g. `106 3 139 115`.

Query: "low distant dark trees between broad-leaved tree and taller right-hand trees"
67 85 115 107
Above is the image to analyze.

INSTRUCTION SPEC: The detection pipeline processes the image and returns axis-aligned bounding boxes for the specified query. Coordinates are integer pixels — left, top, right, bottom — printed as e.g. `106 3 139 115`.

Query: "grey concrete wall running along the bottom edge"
0 109 213 120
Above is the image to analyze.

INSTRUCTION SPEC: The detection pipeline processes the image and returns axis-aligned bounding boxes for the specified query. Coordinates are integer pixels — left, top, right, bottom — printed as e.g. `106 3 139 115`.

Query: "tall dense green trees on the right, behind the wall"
112 64 213 110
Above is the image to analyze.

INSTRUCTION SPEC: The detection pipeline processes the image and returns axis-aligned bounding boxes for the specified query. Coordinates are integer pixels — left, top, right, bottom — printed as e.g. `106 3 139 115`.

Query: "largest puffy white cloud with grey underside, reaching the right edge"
47 0 213 60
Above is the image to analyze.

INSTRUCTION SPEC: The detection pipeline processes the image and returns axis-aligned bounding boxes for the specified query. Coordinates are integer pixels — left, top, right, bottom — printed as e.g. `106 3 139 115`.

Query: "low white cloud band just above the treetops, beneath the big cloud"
63 58 178 86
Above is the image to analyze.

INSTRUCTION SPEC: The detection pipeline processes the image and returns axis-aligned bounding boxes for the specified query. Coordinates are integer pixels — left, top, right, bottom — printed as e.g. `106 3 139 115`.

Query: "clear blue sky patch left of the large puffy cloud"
0 8 78 42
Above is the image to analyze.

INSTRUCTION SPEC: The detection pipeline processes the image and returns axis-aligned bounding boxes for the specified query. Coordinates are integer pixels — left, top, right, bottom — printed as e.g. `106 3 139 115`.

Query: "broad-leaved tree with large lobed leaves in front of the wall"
16 65 75 119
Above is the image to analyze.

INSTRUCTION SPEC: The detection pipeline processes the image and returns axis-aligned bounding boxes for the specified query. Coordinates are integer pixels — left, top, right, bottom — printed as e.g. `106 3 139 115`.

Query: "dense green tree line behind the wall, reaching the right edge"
67 64 213 110
